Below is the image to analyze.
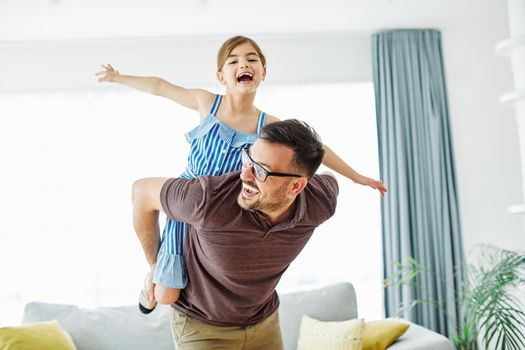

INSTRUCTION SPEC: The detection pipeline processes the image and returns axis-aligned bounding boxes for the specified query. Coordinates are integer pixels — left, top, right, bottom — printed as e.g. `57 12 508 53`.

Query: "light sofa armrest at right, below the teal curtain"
388 318 455 350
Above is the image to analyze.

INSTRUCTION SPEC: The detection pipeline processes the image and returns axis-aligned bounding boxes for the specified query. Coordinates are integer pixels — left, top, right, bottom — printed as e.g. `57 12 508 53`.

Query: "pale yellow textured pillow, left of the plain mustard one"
297 315 365 350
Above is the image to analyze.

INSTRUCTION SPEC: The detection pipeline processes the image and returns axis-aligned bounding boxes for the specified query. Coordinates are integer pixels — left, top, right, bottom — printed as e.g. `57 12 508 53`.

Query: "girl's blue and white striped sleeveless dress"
153 95 266 289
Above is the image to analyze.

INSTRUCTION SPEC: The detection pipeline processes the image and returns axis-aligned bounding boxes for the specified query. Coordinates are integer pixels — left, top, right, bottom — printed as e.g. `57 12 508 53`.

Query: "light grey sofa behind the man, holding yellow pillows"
22 283 454 350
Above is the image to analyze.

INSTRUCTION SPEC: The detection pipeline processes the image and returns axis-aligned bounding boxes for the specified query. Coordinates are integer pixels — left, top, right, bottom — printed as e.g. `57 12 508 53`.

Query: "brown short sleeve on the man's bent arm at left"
160 177 206 227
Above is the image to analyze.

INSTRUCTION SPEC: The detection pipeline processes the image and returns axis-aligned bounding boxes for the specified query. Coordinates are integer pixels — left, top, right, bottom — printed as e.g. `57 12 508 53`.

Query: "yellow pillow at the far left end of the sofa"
0 321 76 350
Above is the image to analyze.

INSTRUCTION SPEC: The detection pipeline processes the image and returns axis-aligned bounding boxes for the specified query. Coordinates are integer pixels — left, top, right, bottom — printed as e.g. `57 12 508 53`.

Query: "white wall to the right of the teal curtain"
443 7 525 252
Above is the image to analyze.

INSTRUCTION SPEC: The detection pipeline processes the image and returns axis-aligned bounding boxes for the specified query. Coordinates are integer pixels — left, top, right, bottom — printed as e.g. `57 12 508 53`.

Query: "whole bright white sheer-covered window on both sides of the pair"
0 83 382 326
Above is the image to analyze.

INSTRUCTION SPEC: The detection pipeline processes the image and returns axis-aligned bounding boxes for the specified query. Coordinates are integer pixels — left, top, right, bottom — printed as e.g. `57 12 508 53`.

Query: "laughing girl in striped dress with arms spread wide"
96 36 386 313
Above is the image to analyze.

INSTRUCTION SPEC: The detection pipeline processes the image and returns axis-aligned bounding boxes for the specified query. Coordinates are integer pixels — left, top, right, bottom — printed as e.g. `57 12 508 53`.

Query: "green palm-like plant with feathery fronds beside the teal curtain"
385 245 525 350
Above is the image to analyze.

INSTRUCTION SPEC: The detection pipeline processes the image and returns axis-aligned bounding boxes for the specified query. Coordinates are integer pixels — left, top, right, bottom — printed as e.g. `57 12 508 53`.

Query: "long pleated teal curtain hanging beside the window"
372 29 465 337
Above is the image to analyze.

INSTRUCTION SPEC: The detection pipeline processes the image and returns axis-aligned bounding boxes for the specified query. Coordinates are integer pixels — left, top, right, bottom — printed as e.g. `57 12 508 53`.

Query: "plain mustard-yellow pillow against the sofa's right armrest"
363 320 409 350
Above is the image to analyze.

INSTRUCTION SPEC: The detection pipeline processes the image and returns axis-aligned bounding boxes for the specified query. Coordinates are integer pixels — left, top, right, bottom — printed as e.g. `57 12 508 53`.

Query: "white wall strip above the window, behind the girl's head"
0 33 372 92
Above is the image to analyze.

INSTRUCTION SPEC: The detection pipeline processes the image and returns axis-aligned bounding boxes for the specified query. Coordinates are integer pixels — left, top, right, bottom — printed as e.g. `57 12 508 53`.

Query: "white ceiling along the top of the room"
0 0 500 43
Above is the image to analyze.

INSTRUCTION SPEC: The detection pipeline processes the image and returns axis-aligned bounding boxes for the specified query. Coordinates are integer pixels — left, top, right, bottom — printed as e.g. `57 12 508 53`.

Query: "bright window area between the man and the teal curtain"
256 83 383 319
